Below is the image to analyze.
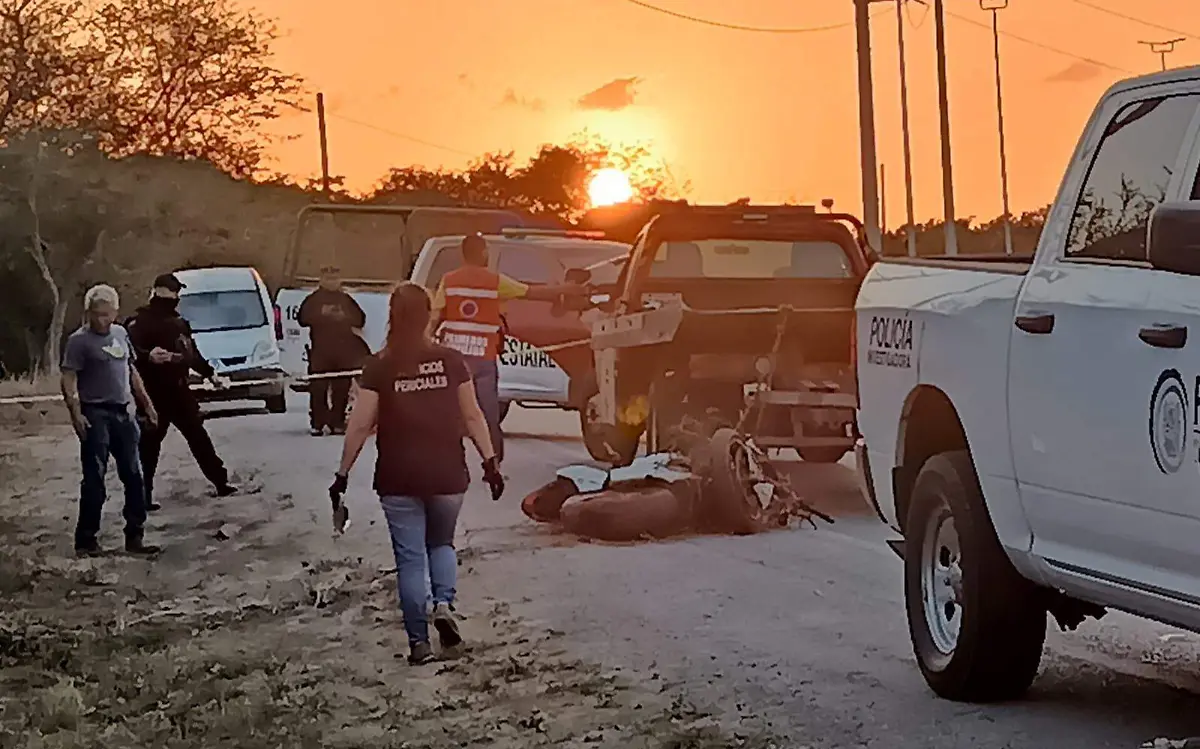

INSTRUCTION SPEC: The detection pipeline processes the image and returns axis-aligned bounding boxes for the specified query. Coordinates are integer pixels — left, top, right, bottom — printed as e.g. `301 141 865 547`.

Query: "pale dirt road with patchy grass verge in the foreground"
0 396 1200 749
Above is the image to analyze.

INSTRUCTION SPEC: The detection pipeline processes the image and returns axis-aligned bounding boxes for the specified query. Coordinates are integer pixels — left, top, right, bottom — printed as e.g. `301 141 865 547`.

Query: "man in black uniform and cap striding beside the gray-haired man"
125 274 238 510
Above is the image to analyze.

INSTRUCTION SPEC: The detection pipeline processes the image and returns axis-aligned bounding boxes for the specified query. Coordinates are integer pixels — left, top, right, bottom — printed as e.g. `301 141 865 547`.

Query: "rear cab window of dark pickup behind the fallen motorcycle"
650 239 854 278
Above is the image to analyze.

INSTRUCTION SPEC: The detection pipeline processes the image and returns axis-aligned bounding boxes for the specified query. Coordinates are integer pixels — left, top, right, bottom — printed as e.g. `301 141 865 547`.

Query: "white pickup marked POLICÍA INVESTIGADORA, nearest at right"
854 67 1200 701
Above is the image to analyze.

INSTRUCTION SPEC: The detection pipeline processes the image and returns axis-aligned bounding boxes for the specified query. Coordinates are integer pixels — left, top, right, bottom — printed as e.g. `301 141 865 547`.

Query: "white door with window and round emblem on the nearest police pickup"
1008 84 1200 581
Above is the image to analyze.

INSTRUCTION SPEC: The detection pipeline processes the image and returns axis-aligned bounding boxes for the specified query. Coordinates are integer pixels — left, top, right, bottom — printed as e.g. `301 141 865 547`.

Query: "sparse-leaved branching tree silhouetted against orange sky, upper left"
0 0 302 176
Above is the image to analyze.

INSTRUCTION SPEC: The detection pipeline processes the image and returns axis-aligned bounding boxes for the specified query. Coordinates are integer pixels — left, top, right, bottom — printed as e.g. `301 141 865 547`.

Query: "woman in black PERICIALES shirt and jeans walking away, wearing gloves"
330 282 504 665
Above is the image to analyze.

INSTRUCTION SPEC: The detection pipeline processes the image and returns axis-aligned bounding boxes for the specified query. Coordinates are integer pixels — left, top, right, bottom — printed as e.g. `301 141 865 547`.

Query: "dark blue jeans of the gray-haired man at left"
76 403 146 549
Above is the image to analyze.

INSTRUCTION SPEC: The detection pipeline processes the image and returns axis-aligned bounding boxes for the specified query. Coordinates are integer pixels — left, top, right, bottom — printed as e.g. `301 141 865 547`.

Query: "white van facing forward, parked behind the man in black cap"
175 268 287 413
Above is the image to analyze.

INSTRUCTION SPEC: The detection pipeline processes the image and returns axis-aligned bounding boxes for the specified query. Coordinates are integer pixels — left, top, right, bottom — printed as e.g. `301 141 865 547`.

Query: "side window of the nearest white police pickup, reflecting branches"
1066 95 1200 260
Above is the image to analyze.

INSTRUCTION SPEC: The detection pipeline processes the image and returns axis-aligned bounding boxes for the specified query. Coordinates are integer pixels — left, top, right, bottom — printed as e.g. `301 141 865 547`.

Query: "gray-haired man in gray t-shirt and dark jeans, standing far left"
62 286 158 556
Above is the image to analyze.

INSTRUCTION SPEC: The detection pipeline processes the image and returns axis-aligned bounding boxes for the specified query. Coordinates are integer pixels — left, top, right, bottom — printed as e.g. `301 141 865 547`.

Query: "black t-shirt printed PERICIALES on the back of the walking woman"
362 346 470 497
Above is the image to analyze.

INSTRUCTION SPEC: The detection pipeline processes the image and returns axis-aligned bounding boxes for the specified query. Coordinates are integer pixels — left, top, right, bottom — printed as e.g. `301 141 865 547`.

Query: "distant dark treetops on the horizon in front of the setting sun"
367 133 686 222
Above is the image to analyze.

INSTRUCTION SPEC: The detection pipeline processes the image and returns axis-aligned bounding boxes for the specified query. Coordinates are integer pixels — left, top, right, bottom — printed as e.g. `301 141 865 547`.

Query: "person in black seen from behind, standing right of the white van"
296 266 371 437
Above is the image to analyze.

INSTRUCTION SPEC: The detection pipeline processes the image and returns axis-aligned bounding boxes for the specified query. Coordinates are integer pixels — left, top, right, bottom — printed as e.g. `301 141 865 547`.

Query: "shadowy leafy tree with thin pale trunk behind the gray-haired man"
0 132 170 375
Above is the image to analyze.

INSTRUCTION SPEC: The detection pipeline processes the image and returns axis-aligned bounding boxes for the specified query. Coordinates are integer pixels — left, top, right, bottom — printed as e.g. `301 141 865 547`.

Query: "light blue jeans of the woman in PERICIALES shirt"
379 495 462 645
